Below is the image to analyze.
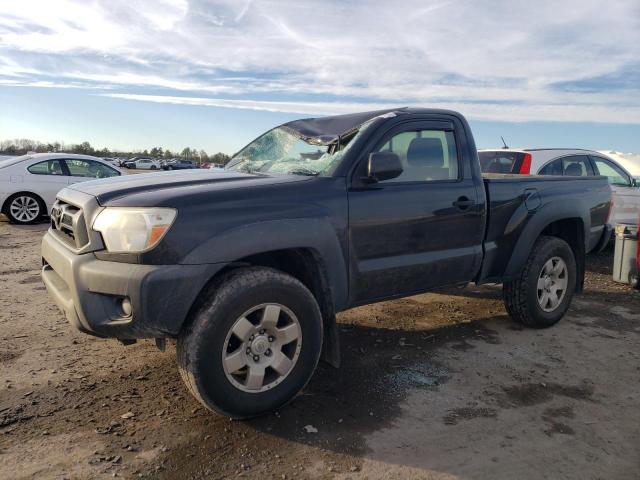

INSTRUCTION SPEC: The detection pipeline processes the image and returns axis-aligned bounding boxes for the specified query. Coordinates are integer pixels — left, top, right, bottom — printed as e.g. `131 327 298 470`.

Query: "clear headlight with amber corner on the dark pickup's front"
93 207 176 253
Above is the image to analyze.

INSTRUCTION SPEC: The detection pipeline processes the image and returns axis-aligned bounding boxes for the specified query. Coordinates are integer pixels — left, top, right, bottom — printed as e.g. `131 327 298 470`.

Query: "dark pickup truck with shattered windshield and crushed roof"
42 108 610 418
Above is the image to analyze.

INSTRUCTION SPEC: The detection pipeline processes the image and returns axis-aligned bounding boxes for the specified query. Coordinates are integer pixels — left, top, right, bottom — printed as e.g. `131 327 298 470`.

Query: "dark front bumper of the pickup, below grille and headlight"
42 231 225 339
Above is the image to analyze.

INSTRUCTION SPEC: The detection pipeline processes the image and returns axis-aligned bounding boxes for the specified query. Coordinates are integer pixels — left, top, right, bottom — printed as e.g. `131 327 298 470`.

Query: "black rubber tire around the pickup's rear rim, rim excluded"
503 236 577 328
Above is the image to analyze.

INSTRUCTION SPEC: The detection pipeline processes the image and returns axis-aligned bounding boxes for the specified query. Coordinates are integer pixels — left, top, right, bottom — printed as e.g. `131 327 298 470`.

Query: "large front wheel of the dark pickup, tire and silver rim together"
177 267 323 418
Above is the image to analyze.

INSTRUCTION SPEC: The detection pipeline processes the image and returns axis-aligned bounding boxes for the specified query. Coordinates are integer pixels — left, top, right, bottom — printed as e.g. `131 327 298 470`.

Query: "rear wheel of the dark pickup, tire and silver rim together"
503 236 577 328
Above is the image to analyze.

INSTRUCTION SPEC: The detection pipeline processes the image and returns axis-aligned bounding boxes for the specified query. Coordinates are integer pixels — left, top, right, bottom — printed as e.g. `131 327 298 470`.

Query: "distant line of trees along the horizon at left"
0 138 231 164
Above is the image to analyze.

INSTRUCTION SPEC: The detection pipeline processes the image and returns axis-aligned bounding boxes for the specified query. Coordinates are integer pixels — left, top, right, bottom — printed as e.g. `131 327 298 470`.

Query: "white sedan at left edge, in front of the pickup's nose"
0 153 122 224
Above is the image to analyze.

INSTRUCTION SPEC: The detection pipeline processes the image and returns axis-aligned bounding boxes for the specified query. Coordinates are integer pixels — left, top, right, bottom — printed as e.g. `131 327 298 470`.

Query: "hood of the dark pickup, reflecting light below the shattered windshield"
69 170 309 205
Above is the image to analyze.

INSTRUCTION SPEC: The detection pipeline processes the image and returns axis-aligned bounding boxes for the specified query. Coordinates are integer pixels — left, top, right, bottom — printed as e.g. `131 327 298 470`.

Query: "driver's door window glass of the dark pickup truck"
378 130 458 183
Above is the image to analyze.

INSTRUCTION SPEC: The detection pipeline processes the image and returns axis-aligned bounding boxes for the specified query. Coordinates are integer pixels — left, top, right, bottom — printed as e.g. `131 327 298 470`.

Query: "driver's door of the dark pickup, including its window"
348 122 484 304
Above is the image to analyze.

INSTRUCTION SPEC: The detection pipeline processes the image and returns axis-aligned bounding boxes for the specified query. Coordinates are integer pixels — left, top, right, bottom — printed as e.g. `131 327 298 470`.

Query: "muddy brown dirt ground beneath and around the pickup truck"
0 221 640 480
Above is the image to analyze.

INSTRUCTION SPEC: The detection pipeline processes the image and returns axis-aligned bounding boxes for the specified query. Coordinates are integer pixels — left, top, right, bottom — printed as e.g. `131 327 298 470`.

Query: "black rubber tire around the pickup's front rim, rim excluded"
177 267 323 418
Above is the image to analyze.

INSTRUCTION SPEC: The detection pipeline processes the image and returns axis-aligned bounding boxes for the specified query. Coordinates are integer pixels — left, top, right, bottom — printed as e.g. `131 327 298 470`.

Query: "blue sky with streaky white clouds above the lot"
0 0 640 153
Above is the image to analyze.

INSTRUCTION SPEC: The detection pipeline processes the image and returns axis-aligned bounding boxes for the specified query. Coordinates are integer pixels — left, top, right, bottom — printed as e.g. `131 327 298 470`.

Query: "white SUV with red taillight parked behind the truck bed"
478 148 640 225
